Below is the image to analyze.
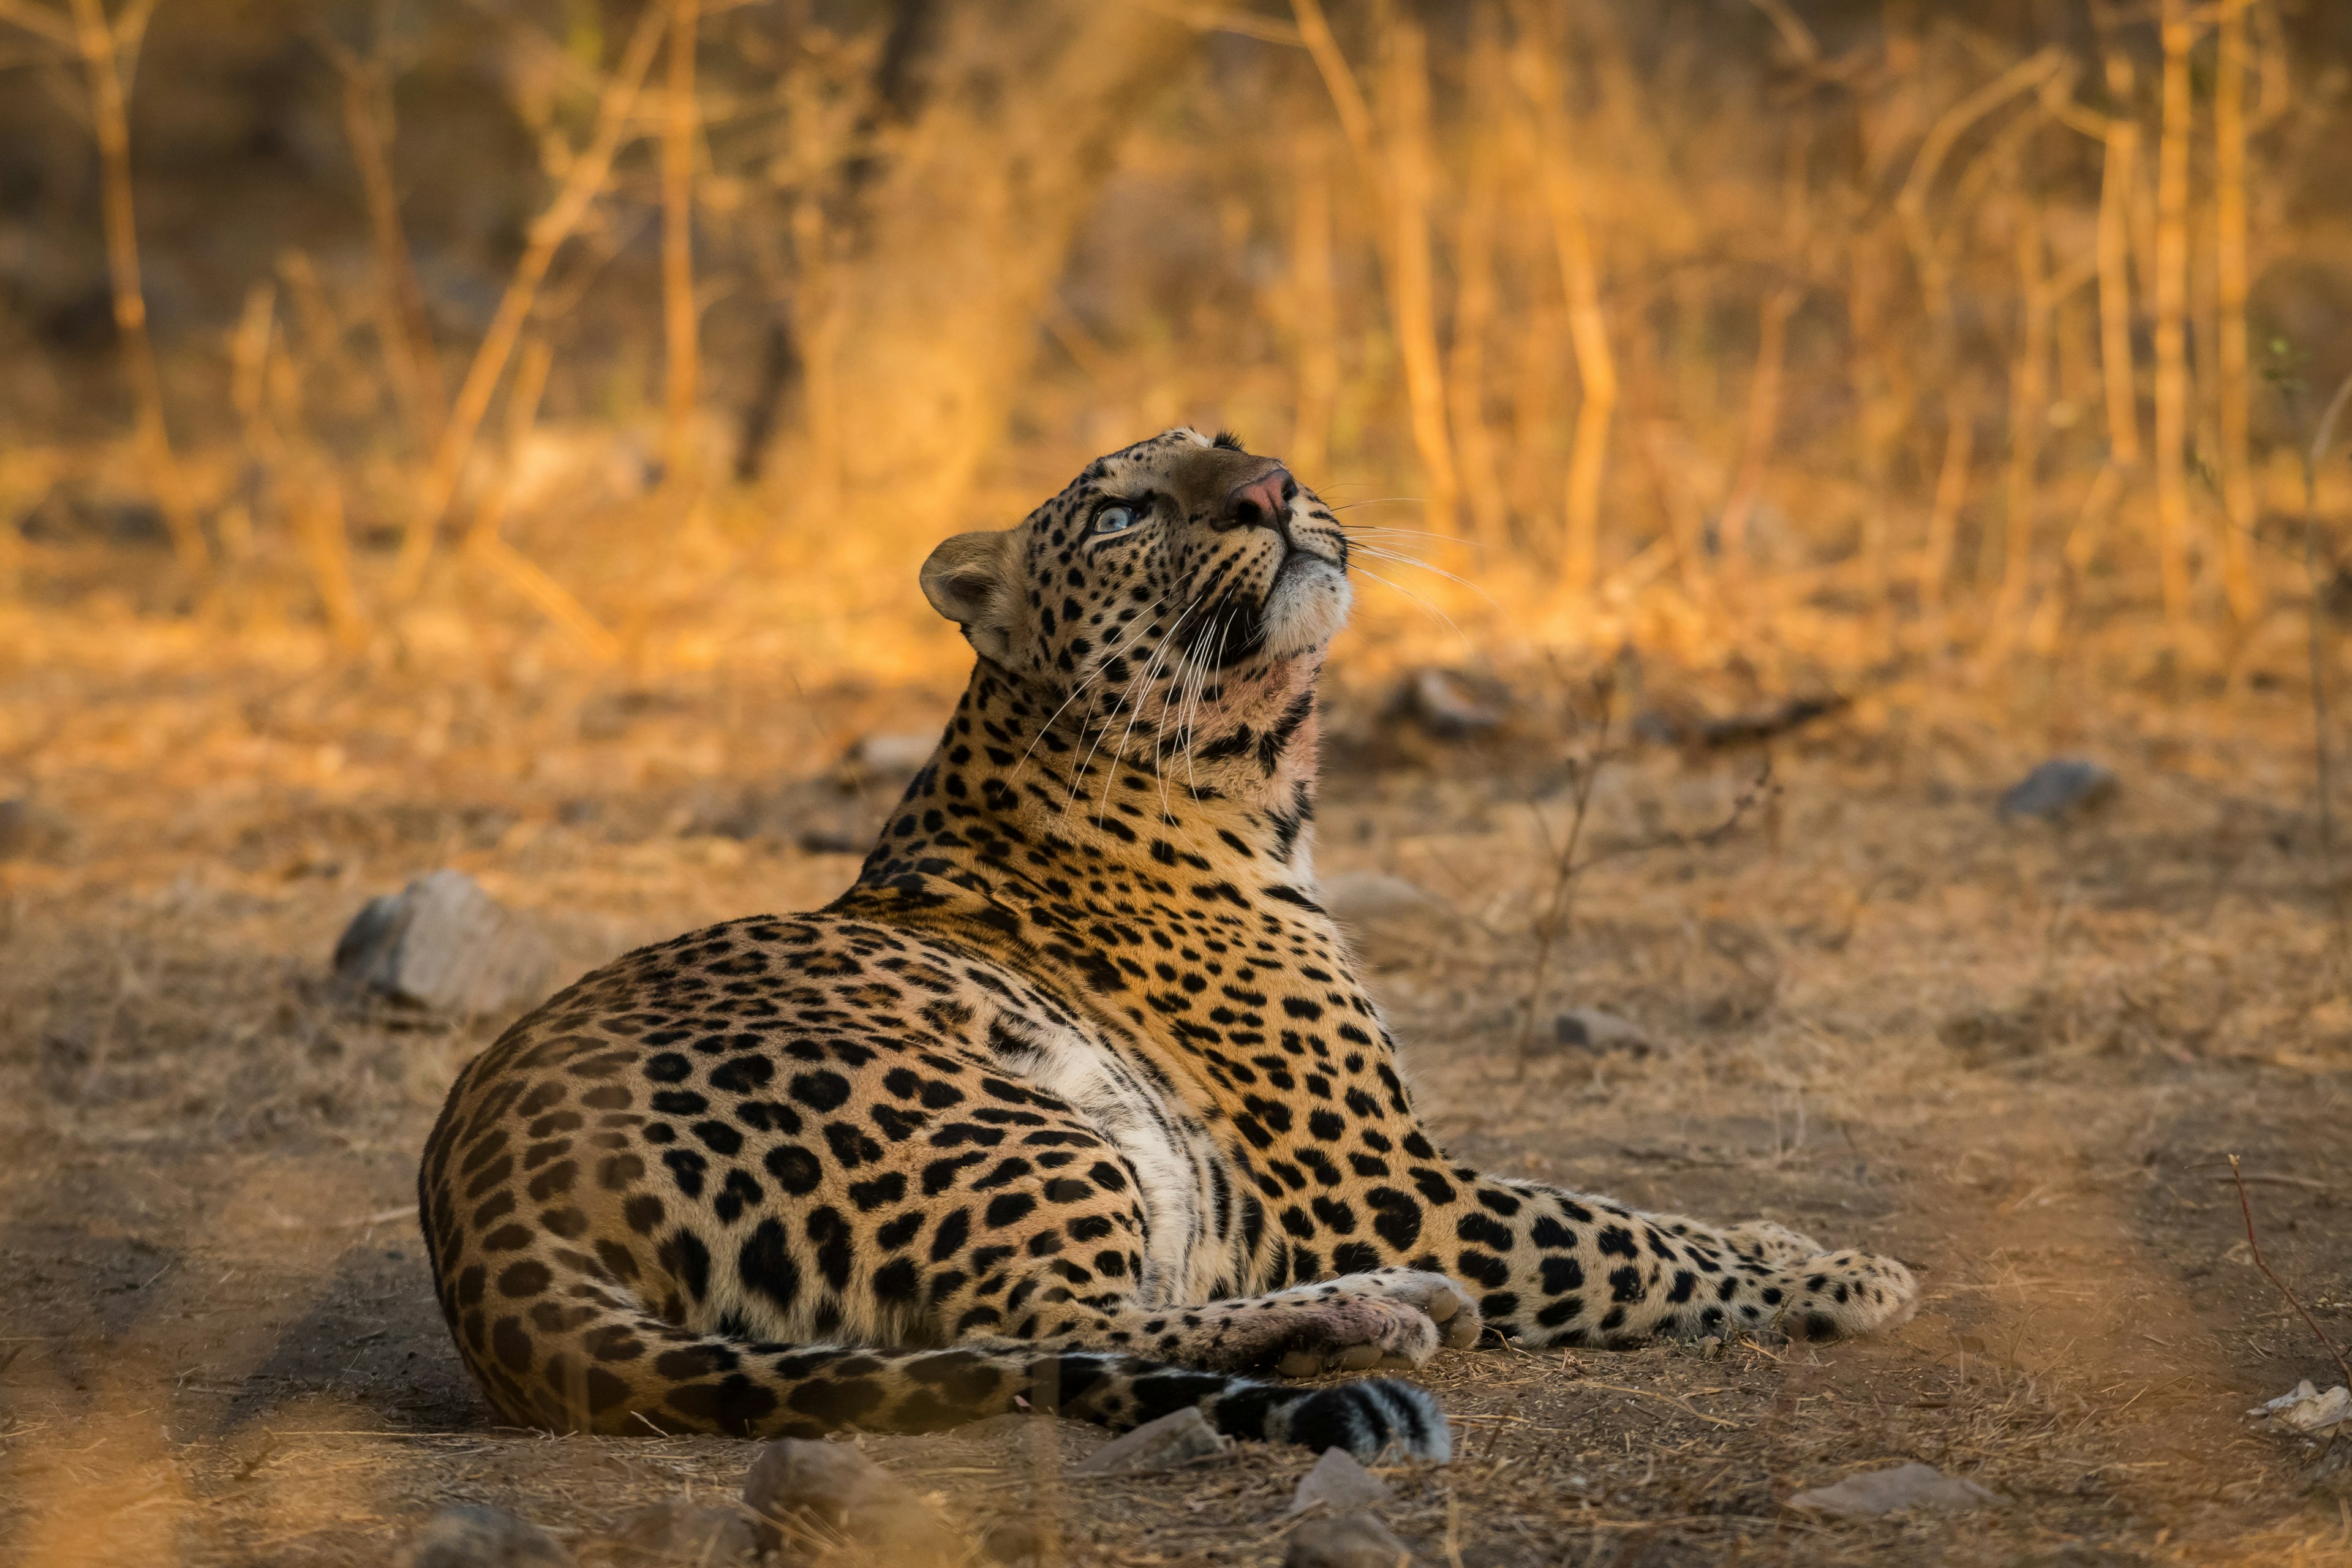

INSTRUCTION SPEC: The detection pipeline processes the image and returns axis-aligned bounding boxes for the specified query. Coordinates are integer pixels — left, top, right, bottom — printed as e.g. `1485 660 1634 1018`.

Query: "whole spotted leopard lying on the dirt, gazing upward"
419 428 1917 1462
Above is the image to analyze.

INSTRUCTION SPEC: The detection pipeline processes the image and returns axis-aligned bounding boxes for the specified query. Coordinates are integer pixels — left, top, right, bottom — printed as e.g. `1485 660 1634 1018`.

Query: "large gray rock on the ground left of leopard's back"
334 870 555 1016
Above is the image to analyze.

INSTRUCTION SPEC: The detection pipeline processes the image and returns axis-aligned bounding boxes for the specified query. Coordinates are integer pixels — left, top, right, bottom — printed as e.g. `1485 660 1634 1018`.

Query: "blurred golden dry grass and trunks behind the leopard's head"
0 0 2352 687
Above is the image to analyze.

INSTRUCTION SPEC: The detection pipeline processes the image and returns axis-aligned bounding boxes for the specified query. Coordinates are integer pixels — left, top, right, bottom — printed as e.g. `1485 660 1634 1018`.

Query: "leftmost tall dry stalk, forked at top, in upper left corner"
70 0 212 571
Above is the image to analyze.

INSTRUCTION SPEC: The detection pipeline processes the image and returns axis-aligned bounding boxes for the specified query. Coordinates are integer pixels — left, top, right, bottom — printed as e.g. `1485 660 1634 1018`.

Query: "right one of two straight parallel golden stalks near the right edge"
2213 0 2260 625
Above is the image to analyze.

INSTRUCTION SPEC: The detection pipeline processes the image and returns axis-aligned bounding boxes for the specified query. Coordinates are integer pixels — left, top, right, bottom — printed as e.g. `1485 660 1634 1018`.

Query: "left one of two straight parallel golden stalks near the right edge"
2154 0 2197 649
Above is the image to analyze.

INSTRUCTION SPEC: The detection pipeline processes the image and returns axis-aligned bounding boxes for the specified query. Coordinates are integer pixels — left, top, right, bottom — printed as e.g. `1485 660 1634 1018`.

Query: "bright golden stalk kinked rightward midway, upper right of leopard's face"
1512 21 1618 595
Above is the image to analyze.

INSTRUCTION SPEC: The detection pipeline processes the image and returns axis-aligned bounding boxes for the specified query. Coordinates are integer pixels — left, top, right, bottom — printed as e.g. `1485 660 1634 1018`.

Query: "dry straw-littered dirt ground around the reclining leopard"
0 630 2352 1568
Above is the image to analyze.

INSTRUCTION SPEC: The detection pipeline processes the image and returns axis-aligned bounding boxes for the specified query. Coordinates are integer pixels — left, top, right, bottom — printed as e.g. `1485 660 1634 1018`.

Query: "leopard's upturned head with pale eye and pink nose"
922 430 1352 774
